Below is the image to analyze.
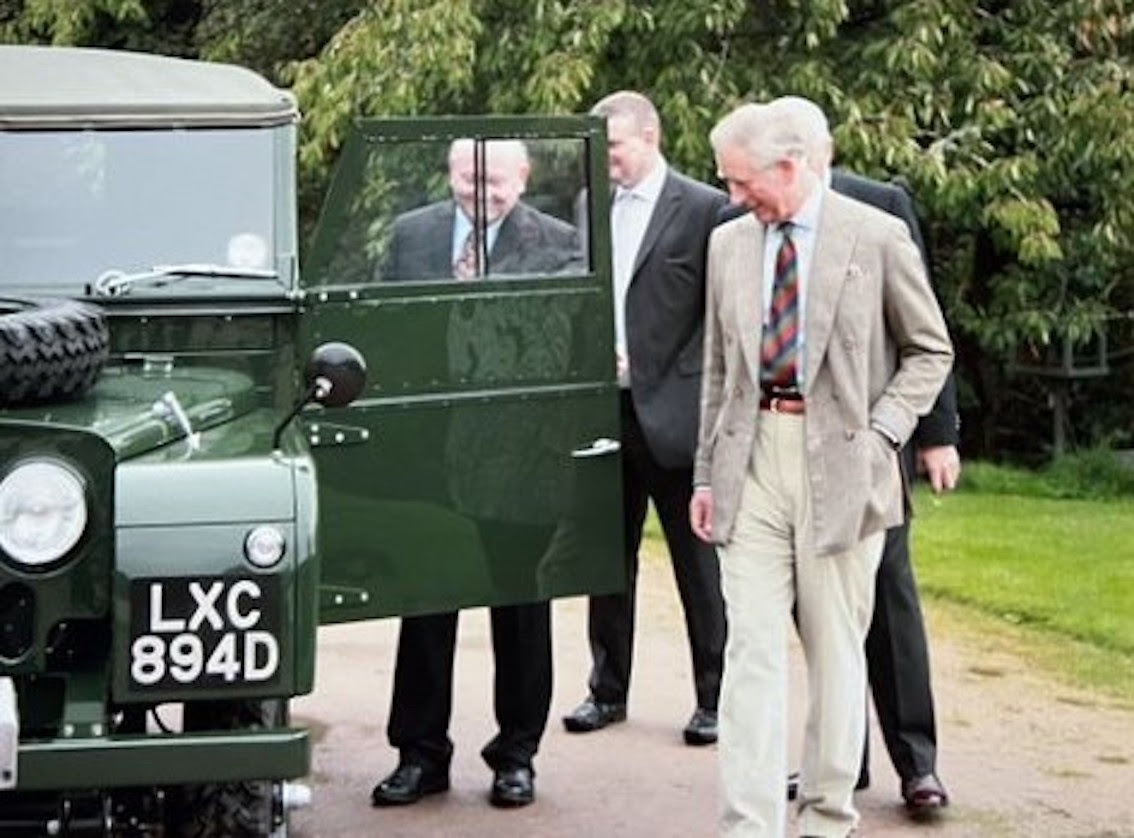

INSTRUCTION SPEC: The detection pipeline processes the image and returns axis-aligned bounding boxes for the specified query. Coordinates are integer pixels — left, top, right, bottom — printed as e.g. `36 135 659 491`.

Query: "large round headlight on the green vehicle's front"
0 459 86 568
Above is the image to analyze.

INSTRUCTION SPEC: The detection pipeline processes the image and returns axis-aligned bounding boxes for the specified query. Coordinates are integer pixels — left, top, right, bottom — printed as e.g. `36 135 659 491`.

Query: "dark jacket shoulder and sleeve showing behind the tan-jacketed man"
831 169 959 462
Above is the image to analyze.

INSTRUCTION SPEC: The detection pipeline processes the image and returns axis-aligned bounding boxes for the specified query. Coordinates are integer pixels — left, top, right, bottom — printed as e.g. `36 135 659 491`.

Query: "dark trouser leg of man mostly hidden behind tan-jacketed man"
866 522 937 780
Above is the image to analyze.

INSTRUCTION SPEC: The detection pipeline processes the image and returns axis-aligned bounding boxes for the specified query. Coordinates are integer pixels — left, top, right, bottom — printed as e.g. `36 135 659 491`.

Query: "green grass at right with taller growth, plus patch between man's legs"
646 469 1134 705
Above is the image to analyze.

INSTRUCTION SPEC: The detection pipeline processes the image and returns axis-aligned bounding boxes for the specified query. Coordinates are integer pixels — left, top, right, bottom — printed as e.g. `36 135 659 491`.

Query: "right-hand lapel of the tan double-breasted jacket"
804 189 857 389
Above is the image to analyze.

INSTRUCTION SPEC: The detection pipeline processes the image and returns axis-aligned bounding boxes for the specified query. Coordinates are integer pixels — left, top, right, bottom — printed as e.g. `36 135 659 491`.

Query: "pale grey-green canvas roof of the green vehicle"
0 45 298 130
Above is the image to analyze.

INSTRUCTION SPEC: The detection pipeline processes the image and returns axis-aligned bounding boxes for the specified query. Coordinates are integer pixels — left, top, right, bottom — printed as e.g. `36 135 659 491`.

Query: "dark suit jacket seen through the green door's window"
380 201 582 281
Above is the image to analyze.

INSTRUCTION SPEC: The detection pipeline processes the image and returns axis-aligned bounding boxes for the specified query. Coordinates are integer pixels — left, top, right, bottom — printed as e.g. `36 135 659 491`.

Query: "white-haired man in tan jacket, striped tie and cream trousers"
689 99 953 838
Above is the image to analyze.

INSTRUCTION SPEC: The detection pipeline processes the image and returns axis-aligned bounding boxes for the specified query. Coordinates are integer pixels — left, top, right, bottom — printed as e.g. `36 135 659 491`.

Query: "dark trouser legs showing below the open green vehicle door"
387 520 551 771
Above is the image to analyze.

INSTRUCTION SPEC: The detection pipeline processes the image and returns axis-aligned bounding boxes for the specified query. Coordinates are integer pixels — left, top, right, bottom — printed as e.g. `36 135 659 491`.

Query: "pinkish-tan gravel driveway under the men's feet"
291 560 1134 838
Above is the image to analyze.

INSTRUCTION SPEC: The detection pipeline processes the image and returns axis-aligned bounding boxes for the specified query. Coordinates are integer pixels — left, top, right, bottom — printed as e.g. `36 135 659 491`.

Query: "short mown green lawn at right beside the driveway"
914 490 1134 700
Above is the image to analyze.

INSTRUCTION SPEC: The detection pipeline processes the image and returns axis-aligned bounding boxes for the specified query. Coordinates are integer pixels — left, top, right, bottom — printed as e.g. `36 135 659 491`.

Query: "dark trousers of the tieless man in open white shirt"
587 392 726 710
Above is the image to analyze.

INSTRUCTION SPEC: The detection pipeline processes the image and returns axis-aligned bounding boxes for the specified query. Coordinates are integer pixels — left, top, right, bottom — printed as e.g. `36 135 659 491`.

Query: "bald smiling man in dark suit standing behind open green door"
371 139 578 807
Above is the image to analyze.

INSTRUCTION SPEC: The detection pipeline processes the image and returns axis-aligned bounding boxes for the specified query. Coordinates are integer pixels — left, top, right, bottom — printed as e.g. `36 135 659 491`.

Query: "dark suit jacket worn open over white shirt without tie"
626 169 726 468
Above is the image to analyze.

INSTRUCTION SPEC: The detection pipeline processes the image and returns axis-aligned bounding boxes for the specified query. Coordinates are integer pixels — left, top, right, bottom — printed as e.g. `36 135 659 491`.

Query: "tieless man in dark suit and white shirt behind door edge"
564 91 725 745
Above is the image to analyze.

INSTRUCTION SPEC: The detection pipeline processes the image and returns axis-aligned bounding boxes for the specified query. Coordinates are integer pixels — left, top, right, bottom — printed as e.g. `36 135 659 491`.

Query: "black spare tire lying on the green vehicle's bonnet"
0 298 110 407
